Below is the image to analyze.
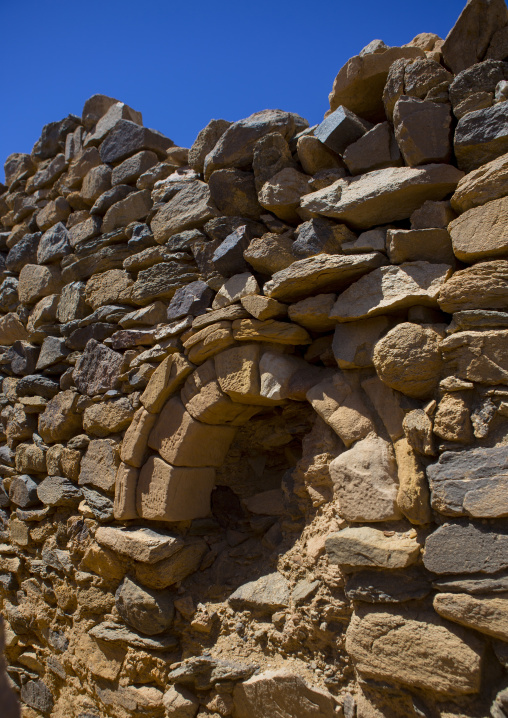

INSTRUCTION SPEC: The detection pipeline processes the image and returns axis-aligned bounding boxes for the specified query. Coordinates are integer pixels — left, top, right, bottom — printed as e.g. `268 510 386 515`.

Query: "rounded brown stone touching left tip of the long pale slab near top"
258 167 310 222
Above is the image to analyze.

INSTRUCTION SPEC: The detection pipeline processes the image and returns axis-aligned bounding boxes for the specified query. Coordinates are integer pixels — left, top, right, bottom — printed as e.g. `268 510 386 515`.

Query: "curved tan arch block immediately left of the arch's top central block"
180 358 259 426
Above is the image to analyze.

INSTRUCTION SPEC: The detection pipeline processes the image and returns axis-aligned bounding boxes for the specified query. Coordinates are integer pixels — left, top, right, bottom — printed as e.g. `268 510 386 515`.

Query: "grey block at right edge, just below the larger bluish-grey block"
423 524 508 574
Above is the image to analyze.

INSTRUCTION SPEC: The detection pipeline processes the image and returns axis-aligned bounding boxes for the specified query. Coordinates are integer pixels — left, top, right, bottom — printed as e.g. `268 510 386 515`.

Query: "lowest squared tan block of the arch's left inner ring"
136 456 215 521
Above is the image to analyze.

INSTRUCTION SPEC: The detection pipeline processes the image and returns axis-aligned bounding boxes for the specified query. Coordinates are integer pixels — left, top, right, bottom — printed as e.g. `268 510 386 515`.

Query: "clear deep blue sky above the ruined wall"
0 0 465 177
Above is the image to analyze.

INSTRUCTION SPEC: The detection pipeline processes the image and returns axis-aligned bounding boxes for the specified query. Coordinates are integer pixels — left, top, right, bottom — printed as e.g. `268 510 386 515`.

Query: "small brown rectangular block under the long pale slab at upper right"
386 229 454 266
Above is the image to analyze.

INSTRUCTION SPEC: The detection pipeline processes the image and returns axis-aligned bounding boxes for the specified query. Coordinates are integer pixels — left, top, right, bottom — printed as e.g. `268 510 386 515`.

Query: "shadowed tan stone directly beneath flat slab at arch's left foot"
134 540 209 592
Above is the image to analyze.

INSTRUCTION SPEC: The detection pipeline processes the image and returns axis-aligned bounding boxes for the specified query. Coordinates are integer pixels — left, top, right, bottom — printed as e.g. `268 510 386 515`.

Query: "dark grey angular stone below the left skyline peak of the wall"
100 120 174 164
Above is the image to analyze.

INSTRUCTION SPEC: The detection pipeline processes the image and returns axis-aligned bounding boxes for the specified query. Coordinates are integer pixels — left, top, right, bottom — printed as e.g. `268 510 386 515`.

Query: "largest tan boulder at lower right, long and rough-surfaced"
346 606 483 696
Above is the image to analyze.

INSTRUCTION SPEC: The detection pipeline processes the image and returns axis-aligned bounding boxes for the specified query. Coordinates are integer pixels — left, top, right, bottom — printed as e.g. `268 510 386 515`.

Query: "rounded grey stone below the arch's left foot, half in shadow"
115 577 175 636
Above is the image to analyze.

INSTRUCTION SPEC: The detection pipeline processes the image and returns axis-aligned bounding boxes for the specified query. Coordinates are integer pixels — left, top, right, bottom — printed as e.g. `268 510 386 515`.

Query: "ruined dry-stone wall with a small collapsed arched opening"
0 0 508 718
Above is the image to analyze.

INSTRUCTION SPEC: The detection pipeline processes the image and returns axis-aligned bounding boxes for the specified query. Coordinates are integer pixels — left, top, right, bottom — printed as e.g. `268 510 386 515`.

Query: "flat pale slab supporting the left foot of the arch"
95 526 184 563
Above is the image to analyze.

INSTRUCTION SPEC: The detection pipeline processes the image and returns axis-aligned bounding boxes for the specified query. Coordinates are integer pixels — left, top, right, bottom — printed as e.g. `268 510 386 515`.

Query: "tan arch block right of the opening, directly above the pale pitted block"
307 372 375 447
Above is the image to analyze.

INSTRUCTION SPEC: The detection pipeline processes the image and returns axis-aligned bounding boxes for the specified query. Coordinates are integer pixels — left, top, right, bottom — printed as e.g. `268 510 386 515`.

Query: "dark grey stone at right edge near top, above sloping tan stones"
454 102 508 172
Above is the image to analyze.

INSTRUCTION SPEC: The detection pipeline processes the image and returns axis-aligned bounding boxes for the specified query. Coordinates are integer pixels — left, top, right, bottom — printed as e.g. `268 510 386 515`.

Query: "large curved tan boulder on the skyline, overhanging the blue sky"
329 46 424 122
